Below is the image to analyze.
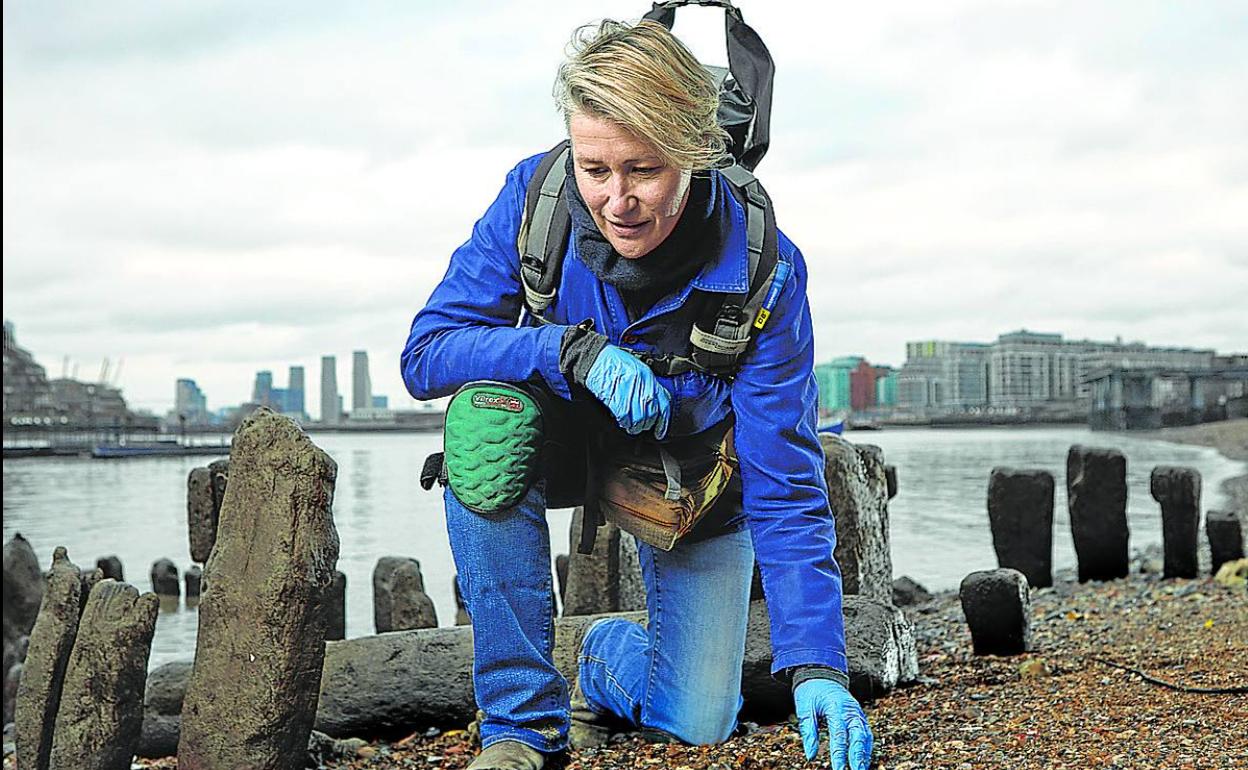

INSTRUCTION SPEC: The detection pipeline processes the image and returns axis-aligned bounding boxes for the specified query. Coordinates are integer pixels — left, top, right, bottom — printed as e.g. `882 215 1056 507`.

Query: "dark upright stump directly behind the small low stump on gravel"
988 468 1053 588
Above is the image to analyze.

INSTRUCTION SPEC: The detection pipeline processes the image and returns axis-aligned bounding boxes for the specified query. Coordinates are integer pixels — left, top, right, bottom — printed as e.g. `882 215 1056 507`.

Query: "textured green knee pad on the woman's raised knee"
443 382 543 514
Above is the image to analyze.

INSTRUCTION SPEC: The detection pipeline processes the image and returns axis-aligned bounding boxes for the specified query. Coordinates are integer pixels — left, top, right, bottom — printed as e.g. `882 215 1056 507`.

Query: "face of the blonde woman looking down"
569 112 689 260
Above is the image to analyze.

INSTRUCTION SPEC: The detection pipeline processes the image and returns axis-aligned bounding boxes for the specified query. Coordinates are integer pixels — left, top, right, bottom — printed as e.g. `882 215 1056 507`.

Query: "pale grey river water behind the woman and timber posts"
4 427 1244 668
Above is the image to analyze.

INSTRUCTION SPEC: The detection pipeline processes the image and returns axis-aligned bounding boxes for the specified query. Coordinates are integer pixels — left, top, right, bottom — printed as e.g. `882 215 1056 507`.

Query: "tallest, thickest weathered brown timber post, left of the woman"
178 408 338 770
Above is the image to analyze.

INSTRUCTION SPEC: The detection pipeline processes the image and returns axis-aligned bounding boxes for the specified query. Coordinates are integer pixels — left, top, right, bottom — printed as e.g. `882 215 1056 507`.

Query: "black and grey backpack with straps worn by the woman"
517 0 790 379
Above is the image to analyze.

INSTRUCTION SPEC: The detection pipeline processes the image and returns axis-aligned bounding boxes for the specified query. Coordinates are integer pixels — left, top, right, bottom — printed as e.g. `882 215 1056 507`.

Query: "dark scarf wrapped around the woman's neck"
564 154 728 319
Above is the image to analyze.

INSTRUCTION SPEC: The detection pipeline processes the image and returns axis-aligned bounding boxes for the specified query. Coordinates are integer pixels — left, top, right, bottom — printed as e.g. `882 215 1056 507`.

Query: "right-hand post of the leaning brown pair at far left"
47 579 160 770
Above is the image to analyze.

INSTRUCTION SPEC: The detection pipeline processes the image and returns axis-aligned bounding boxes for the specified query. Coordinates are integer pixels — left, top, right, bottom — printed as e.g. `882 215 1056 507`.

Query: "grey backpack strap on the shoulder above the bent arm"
515 140 572 321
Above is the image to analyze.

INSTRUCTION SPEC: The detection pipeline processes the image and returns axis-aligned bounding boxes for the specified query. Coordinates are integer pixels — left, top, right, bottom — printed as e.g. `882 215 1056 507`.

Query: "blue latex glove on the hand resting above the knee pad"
585 344 671 438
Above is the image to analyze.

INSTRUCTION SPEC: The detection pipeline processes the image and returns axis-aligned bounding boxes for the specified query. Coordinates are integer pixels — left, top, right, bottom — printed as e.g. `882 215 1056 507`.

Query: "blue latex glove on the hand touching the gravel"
792 679 875 770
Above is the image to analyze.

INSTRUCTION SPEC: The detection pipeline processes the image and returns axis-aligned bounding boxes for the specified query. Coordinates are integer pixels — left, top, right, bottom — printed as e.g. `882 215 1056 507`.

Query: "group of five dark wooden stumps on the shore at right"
958 444 1244 655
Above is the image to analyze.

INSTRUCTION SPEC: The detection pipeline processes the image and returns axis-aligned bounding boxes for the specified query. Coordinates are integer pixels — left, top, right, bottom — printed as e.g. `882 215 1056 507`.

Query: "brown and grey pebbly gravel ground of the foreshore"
107 574 1248 770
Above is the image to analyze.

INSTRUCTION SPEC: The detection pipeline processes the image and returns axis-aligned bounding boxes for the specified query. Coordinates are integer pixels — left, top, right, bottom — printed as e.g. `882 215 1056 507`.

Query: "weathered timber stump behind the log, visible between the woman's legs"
563 508 645 616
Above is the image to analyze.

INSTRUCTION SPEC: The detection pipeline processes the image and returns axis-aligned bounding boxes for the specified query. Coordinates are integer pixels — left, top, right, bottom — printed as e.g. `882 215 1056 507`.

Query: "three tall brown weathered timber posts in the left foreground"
8 409 338 770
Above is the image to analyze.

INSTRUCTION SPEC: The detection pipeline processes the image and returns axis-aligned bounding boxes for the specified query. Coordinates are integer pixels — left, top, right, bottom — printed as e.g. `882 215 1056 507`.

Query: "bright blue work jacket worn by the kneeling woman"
401 148 847 674
